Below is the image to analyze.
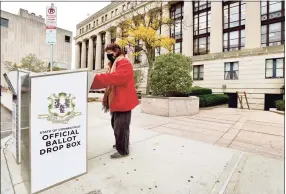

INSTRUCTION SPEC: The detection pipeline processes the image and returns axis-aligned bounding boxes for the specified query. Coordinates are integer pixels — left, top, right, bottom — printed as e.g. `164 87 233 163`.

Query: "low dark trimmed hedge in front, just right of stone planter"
199 94 228 107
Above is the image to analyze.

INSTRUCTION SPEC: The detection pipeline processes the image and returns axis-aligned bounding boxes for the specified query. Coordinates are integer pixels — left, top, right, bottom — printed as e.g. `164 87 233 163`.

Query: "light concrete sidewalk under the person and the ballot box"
1 103 284 194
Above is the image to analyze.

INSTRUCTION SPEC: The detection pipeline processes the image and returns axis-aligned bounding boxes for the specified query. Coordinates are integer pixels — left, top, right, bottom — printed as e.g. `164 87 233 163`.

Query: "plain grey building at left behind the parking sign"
1 9 73 85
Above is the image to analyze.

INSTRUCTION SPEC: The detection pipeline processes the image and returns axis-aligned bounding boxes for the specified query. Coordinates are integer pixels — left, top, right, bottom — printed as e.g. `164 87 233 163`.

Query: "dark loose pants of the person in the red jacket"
111 111 131 155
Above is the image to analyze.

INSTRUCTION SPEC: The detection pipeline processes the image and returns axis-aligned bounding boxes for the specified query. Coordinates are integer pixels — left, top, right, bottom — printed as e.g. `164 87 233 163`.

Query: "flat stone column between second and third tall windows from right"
210 1 223 53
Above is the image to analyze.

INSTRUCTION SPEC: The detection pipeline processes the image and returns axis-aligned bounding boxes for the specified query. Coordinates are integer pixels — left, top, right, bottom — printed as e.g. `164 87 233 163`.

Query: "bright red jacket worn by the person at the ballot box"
91 58 139 112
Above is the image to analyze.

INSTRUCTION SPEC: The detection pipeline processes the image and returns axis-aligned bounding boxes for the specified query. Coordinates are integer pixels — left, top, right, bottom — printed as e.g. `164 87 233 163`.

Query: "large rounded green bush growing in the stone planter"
150 53 192 97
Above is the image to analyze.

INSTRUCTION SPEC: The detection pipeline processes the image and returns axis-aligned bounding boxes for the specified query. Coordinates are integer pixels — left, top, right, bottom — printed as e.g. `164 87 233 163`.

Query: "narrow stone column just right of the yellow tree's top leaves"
182 1 194 57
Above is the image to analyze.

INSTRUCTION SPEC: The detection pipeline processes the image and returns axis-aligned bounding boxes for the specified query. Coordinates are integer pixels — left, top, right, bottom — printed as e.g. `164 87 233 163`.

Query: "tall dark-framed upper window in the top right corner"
261 1 285 47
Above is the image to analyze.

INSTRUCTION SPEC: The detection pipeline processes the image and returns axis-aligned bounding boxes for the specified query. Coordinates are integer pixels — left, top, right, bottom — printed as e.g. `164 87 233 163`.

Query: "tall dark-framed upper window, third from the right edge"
193 1 211 55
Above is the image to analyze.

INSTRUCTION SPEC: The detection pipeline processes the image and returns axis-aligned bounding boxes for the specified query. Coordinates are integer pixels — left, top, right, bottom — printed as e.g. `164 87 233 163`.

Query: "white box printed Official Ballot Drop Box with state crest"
20 69 88 194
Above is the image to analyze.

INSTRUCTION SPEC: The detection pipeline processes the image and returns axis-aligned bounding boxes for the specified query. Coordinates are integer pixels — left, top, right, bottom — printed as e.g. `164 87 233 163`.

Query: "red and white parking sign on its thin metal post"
46 3 57 71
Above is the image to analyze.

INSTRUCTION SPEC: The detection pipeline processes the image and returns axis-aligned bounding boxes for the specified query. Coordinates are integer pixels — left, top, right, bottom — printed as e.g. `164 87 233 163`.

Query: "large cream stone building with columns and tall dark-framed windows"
74 0 285 110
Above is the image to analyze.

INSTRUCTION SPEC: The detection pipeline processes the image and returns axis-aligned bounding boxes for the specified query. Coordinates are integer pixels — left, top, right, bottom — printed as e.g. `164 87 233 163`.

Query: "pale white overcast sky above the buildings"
1 0 110 68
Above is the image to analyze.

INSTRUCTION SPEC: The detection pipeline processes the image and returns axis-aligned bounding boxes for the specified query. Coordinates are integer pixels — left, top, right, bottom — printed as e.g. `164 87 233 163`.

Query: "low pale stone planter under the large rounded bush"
141 96 200 117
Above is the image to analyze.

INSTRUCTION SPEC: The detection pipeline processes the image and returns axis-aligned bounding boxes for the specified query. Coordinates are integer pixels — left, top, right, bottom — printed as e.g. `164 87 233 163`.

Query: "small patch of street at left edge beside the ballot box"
1 106 12 139
